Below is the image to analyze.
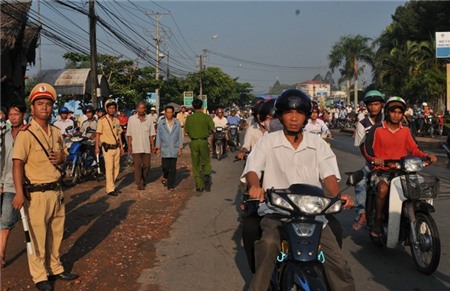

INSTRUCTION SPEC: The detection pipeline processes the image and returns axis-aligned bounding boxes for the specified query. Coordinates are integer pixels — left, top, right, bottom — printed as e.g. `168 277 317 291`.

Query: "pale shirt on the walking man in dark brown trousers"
127 114 156 154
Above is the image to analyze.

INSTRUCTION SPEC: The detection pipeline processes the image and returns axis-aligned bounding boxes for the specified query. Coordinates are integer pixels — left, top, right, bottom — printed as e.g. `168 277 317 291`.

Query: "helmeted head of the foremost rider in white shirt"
275 89 312 137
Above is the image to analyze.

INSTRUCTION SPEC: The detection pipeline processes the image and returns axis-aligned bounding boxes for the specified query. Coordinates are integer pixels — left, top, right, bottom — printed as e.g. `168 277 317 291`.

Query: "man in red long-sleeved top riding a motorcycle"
364 96 437 238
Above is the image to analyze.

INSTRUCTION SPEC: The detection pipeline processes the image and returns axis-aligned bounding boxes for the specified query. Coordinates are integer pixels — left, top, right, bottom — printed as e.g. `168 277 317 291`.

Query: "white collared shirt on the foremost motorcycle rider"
242 130 341 190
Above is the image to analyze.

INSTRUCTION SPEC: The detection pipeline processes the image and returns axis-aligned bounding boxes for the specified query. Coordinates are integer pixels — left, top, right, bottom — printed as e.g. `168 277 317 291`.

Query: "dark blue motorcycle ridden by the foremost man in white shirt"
260 172 363 290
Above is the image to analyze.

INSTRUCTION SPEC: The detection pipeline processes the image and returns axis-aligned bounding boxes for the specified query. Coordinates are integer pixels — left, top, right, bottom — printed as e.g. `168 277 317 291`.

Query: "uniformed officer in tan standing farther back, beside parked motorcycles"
95 99 124 196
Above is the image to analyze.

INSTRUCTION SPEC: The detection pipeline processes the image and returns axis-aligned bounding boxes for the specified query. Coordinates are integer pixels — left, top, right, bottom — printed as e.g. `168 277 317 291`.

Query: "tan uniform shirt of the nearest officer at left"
12 120 68 184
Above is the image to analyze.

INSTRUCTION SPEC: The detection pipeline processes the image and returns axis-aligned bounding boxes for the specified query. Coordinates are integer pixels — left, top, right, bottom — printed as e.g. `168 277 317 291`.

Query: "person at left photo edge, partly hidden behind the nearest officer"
0 103 27 268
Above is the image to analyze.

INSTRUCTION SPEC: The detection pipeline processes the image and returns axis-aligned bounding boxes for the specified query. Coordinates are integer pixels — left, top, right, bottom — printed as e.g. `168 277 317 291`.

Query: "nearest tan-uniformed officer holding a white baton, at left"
12 83 78 291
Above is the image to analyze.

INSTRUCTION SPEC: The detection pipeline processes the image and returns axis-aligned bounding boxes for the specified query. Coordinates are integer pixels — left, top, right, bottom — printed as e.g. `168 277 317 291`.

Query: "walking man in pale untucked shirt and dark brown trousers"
127 101 156 190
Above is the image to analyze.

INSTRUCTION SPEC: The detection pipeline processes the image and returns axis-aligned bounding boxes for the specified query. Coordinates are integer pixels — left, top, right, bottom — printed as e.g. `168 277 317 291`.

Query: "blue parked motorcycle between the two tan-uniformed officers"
63 128 104 186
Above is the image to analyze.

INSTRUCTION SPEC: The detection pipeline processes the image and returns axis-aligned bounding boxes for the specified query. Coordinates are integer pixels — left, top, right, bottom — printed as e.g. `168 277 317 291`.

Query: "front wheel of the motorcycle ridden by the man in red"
411 212 441 275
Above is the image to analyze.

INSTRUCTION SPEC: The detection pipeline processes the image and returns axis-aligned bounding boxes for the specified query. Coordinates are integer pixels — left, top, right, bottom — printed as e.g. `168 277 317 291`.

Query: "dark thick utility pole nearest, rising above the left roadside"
89 0 98 108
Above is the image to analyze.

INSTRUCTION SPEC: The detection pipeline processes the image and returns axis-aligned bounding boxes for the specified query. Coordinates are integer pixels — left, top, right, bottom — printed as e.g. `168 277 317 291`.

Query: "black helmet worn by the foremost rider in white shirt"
275 89 312 118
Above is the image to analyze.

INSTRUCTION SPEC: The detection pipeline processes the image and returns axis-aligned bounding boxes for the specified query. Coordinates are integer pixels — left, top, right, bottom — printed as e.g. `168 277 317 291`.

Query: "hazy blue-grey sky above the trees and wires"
28 0 405 93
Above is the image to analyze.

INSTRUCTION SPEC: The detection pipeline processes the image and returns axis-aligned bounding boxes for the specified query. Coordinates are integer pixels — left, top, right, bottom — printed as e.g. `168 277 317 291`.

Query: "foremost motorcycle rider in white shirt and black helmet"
242 89 355 290
